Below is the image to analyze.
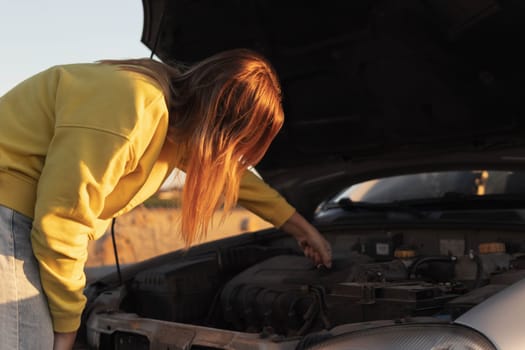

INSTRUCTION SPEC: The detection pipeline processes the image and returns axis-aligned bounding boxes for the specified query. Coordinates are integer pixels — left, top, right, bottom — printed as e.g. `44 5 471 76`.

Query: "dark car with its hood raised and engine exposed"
75 0 525 350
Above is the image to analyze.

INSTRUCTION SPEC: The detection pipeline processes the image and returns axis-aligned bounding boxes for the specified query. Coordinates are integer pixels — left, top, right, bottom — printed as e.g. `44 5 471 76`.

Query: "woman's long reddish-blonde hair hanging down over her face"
102 49 284 246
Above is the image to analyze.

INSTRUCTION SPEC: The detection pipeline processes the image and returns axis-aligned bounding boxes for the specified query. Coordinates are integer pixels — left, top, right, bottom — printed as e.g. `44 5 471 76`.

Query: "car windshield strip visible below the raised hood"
330 170 525 203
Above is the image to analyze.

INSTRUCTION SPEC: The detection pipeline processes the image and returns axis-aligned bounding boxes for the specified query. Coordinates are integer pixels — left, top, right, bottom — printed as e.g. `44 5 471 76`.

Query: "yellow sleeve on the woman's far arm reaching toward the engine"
239 170 295 227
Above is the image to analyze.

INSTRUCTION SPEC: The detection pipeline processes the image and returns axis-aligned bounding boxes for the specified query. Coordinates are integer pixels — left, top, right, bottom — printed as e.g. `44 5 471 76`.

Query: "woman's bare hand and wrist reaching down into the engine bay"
280 212 332 268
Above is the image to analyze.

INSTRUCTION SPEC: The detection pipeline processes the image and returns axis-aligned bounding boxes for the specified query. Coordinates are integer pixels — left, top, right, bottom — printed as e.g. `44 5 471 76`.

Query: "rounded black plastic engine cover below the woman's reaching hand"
221 255 350 335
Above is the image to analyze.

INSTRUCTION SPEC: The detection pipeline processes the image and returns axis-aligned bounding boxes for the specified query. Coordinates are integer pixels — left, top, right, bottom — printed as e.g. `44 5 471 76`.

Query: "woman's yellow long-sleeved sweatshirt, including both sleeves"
0 64 294 332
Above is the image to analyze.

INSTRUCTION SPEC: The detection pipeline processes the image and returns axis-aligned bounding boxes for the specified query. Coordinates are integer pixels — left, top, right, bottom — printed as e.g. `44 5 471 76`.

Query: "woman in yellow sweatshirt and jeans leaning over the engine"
0 49 331 349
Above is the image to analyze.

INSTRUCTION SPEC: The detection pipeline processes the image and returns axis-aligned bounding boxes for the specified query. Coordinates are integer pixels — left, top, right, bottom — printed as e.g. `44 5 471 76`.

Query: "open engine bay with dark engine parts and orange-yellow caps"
116 228 525 338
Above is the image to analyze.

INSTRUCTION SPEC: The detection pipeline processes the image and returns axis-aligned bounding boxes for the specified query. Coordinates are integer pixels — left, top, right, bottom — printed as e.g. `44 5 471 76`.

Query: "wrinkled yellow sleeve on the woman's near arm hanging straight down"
31 127 131 332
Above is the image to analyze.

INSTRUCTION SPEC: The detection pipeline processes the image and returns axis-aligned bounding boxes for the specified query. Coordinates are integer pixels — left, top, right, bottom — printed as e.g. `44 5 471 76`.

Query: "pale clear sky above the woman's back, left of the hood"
0 0 150 95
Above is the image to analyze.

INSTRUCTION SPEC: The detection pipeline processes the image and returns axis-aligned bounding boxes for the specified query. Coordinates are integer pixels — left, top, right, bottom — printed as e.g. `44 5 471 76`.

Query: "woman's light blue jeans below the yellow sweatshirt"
0 205 53 350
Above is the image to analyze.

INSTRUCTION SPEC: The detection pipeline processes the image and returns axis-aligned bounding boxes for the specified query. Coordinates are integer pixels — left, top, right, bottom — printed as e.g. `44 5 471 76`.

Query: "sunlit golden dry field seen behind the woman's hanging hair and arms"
86 206 271 267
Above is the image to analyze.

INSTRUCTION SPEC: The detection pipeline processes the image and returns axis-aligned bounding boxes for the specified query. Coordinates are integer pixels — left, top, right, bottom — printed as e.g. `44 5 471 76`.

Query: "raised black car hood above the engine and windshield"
142 0 525 177
